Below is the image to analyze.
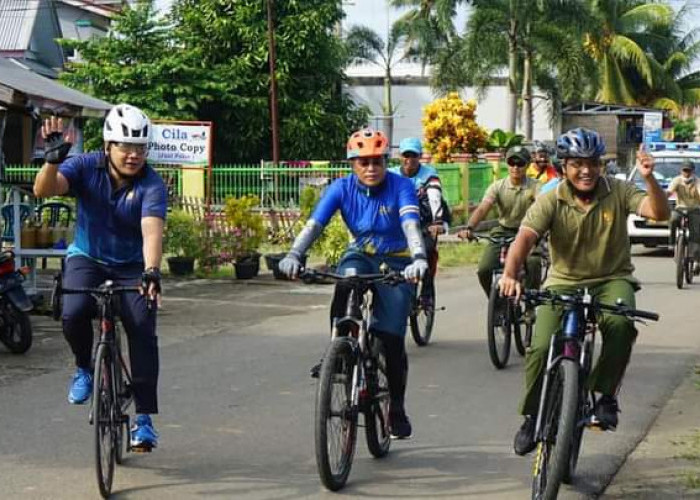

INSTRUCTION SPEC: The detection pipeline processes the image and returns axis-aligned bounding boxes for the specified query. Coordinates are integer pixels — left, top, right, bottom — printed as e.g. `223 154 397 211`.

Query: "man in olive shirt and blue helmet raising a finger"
499 129 669 455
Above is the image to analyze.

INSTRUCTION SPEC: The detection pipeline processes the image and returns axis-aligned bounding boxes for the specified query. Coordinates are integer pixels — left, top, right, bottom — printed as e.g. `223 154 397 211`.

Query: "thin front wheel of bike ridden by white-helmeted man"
92 344 118 498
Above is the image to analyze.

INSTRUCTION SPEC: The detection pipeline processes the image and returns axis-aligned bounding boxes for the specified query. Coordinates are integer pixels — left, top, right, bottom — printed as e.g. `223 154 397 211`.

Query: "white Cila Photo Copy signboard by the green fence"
148 123 211 167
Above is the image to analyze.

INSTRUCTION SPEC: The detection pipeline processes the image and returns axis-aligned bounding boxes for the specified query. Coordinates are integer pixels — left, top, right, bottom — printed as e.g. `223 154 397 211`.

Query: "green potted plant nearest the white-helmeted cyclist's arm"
163 210 199 276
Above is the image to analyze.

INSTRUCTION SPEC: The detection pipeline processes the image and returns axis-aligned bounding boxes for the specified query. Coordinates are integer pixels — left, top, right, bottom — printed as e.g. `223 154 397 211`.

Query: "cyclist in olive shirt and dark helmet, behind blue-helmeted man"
457 146 542 297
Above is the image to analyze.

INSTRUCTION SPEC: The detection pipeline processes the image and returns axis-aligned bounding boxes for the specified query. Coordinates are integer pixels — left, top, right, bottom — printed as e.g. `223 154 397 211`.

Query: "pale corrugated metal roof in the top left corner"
0 0 39 50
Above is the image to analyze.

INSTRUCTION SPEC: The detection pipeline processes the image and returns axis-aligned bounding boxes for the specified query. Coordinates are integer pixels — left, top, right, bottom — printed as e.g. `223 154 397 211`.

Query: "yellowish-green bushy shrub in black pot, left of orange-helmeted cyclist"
224 196 265 279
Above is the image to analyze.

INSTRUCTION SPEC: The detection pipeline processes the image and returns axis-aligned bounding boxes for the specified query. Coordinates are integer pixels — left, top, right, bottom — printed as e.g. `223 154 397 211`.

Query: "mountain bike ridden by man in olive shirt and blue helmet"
523 290 659 500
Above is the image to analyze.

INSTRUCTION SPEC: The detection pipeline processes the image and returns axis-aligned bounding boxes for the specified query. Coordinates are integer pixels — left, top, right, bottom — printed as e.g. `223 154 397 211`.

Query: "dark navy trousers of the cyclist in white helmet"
63 256 159 413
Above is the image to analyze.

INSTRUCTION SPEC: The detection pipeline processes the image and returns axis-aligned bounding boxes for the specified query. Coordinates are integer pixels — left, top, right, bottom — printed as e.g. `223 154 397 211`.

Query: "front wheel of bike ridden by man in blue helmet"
532 359 579 500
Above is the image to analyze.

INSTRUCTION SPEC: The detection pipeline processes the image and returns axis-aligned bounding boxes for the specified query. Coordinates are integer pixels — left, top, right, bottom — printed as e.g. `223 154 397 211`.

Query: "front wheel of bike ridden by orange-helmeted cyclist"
315 338 358 491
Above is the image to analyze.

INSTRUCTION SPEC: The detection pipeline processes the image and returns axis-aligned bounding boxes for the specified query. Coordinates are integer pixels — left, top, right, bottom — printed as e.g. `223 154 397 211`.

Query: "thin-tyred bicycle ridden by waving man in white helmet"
55 280 150 498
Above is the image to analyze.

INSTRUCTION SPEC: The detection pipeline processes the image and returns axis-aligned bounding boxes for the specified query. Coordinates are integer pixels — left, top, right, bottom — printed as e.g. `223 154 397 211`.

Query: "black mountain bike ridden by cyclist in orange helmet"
301 269 405 491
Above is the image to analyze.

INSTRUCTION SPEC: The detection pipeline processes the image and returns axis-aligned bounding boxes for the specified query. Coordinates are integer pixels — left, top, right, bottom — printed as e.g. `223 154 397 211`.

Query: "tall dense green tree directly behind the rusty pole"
171 0 367 161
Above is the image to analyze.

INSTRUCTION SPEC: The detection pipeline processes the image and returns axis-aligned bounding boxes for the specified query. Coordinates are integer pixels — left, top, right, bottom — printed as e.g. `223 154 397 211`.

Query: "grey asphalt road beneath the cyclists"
0 252 700 500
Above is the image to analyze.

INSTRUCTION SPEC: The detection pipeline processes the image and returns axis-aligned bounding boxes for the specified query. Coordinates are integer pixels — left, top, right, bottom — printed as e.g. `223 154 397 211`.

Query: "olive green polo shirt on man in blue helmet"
522 177 647 286
